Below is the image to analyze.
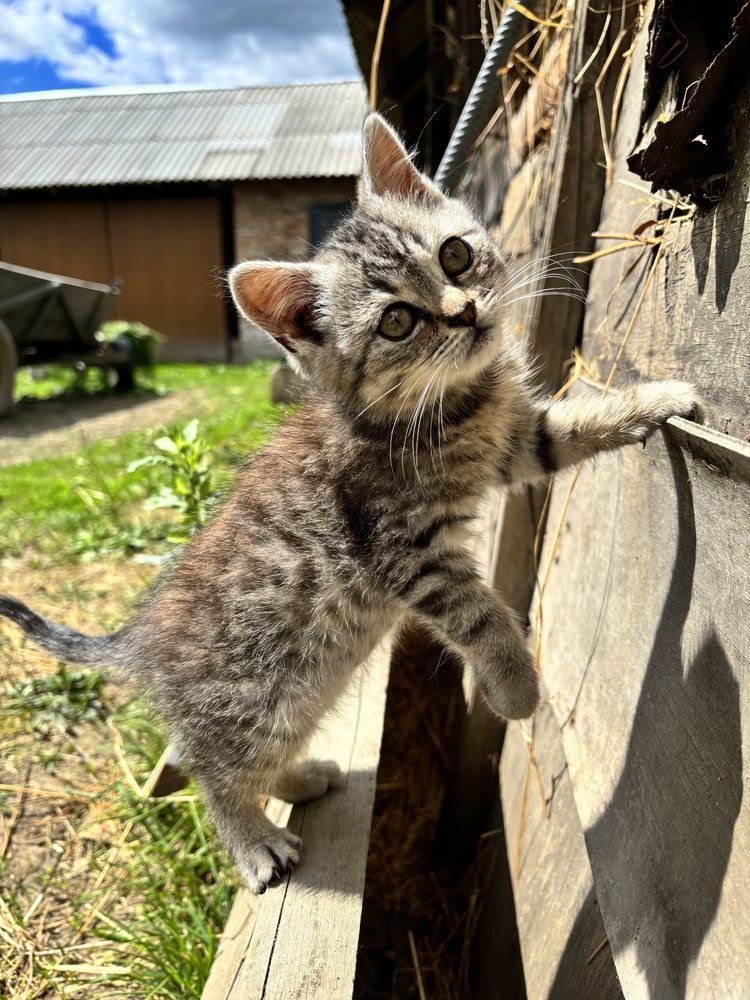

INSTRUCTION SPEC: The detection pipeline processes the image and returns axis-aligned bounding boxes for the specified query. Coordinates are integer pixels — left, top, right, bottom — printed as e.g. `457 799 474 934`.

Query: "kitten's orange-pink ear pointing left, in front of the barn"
229 260 322 354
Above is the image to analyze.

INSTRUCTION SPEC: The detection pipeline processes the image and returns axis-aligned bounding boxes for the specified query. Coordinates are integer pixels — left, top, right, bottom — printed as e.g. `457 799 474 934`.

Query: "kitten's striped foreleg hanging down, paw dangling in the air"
399 552 539 719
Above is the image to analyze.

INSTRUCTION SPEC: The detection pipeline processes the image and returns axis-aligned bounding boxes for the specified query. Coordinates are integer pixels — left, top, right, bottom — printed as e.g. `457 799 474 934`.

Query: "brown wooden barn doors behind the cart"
0 197 228 361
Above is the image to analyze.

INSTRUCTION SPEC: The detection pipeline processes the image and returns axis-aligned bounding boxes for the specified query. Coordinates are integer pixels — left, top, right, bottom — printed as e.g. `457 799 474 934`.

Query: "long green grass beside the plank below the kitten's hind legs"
79 699 238 1000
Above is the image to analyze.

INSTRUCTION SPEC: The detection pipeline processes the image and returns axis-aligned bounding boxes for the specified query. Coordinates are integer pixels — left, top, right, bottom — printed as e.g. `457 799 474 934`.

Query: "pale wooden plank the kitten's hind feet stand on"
203 641 391 1000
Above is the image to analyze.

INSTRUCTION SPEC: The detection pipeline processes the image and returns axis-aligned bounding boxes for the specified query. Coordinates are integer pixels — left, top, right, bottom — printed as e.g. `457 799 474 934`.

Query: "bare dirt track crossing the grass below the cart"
0 389 202 466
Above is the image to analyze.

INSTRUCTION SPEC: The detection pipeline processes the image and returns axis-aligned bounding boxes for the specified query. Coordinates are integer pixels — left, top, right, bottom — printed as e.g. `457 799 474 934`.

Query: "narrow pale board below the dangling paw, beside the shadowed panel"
500 705 622 1000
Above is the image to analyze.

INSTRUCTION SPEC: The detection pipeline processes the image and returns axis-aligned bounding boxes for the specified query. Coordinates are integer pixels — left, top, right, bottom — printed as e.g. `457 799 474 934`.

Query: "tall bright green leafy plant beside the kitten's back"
128 420 213 541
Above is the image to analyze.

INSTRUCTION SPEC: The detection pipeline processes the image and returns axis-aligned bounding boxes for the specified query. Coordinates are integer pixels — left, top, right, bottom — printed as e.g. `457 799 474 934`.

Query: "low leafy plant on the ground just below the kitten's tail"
3 663 107 735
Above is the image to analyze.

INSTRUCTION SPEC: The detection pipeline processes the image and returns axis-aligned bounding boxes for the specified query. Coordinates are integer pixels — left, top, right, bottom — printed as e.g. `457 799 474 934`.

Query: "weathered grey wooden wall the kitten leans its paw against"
465 3 750 1000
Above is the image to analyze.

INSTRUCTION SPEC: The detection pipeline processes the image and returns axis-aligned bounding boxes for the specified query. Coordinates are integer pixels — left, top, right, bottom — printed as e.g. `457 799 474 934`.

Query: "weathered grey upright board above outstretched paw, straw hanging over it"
583 4 750 438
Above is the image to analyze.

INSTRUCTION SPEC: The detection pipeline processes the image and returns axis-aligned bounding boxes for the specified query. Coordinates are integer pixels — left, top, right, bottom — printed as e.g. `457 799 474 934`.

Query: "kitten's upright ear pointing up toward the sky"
357 111 443 202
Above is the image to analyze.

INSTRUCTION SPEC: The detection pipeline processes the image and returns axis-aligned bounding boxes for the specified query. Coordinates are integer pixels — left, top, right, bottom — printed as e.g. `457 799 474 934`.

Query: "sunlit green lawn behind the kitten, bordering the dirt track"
0 362 284 563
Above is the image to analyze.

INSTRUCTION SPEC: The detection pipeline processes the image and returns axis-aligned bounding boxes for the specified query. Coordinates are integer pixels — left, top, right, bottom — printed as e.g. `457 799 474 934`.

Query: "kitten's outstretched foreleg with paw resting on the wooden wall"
500 382 702 483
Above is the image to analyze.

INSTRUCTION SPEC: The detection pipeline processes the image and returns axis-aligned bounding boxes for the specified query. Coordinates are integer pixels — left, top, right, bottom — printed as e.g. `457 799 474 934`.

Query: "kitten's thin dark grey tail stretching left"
0 594 125 666
